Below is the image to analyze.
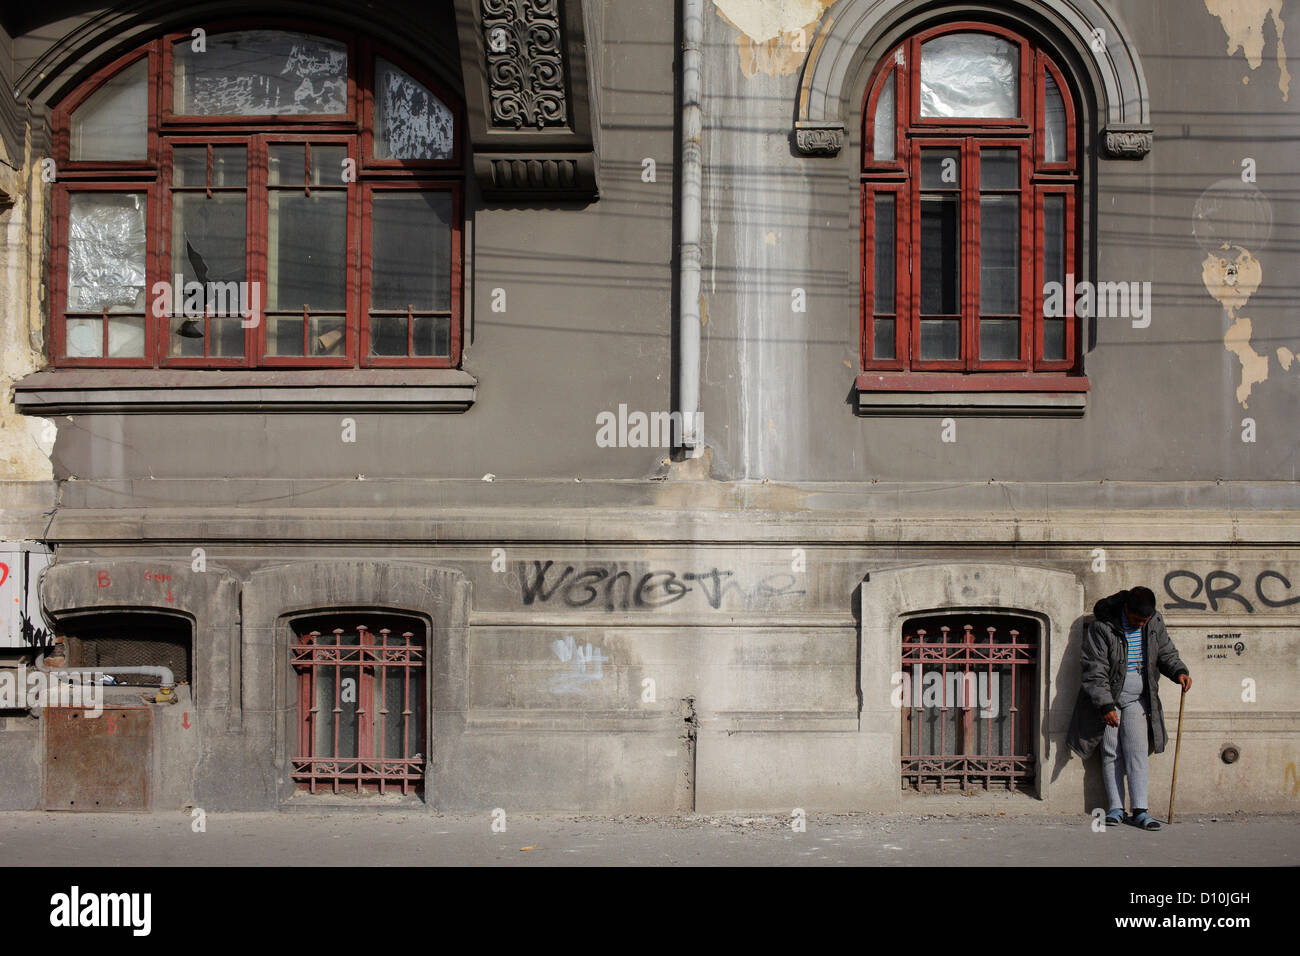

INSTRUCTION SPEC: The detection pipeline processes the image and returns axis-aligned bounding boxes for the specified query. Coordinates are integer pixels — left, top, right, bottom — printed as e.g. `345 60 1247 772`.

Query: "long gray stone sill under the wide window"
14 368 478 416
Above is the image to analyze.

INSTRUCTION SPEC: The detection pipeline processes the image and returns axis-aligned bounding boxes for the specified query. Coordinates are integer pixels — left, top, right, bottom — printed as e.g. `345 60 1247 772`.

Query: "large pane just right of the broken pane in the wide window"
267 191 347 312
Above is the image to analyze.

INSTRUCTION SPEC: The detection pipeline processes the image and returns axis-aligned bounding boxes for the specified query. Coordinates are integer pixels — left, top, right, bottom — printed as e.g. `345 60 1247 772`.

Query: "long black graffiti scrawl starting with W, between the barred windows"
519 561 807 611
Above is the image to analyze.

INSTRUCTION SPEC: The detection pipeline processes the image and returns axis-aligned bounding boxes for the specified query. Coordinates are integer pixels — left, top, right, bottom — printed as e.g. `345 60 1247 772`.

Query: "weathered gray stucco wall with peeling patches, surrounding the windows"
0 0 1300 812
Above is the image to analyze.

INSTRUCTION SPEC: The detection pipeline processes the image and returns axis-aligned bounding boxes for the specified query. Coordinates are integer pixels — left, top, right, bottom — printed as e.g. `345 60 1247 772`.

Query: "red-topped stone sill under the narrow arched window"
855 372 1088 418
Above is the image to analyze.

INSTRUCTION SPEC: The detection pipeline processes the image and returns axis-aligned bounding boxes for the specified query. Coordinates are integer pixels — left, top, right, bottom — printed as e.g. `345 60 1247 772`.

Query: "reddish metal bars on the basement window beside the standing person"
901 622 1037 790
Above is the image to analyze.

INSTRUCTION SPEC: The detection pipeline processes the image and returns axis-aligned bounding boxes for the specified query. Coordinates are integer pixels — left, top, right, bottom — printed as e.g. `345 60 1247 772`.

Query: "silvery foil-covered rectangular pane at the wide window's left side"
68 193 144 312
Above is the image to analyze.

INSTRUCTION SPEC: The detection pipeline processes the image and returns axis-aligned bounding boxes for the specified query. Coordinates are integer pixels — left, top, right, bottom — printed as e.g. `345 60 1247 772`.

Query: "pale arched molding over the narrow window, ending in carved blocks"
794 0 1152 159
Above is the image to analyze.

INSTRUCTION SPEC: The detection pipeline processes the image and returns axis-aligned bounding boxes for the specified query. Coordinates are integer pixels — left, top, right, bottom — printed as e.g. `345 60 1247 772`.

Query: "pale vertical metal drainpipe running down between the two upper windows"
677 0 705 454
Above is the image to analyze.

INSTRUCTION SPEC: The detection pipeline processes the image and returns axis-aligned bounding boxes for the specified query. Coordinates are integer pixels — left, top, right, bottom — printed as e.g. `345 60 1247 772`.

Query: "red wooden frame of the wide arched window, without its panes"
49 20 467 369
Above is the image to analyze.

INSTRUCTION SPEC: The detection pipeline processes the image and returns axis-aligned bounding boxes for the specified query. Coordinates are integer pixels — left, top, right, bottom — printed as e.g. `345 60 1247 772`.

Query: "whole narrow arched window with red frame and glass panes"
862 22 1079 390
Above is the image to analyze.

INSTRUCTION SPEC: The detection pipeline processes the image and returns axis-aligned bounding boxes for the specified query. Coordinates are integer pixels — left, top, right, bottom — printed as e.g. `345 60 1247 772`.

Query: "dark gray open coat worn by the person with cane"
1066 591 1190 757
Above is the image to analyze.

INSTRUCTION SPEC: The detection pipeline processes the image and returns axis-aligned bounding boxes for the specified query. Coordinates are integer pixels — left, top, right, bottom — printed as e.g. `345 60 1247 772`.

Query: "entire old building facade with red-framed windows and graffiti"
0 0 1300 813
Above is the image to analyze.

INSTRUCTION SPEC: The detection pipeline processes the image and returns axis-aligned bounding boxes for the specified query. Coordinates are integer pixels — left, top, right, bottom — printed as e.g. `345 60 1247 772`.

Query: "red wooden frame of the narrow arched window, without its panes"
859 21 1086 390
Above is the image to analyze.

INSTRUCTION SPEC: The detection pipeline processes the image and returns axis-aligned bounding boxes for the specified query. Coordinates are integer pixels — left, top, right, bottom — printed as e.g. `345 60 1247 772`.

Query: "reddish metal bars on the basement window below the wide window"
290 624 425 795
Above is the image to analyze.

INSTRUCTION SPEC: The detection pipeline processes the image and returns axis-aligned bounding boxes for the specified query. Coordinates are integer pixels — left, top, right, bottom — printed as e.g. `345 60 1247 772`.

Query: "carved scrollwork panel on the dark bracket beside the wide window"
481 0 568 130
